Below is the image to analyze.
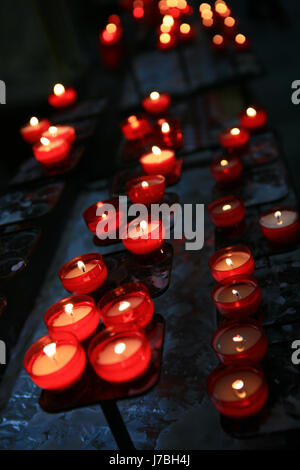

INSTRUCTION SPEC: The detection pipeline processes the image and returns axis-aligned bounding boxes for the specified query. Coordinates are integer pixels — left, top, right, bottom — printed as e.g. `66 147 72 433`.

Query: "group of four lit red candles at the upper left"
20 83 77 168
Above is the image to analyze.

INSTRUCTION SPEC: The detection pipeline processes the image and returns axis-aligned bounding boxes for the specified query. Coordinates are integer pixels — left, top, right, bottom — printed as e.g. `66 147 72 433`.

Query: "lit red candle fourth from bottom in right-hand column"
209 245 254 282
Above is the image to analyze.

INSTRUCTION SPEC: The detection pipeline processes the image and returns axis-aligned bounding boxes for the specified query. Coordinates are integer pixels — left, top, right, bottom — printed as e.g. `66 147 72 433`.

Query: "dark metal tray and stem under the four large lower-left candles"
39 314 165 450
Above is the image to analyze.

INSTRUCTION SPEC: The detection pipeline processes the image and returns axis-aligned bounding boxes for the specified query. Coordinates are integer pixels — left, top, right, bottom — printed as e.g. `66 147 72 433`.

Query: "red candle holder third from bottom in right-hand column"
211 276 261 320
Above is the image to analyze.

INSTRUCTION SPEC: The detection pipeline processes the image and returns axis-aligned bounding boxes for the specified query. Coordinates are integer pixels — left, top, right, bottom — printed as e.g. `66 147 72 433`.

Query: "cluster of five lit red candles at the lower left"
24 276 154 391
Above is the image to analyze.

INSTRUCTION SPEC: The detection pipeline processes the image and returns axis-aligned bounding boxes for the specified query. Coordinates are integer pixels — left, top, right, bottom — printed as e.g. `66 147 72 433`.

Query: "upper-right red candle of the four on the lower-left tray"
98 282 154 328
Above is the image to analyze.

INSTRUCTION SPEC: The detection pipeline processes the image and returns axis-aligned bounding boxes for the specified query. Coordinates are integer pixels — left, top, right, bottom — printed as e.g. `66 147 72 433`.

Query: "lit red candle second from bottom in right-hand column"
212 321 268 365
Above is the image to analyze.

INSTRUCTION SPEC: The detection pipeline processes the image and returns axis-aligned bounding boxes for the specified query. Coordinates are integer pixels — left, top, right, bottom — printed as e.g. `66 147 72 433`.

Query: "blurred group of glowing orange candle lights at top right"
199 0 251 52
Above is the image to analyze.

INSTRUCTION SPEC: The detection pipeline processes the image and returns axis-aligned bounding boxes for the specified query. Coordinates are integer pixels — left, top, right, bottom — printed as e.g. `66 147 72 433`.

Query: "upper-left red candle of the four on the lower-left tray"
44 295 100 341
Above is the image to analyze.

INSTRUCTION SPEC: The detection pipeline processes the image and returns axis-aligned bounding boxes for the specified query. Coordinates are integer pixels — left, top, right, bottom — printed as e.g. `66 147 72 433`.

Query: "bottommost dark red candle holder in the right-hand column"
207 365 268 419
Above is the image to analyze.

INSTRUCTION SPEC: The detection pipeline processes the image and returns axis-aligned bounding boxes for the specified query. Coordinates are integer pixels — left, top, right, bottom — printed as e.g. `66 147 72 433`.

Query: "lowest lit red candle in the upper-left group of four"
33 137 70 167
